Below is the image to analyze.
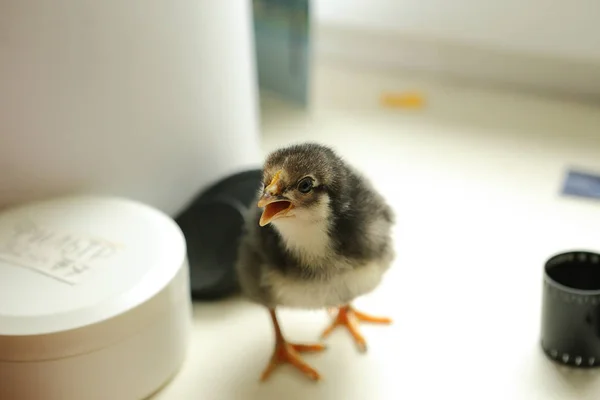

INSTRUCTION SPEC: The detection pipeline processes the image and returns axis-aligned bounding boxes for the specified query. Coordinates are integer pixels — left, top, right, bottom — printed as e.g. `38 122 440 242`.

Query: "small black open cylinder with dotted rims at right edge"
541 251 600 368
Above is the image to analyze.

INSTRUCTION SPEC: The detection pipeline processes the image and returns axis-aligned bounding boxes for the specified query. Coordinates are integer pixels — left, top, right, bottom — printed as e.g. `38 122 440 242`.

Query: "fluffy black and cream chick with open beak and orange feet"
237 143 394 380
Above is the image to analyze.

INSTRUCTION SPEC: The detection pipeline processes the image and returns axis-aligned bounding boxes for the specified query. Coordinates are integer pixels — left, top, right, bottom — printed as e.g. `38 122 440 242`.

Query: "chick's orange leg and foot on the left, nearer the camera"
261 309 325 381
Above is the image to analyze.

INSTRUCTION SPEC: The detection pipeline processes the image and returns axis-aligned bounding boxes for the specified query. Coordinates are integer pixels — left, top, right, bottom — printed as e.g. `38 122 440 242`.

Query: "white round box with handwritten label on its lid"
0 197 191 400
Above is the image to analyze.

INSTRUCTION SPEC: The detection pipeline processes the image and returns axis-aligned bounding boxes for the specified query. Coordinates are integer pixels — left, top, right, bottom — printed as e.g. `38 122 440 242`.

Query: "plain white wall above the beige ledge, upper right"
314 0 600 61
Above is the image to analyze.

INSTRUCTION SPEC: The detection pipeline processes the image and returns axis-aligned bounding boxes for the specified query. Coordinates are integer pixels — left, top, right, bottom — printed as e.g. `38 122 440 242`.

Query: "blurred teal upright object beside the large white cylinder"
253 0 310 106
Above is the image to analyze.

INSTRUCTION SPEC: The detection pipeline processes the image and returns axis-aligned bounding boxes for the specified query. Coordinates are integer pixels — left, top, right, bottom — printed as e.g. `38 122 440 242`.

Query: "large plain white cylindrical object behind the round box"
0 0 260 215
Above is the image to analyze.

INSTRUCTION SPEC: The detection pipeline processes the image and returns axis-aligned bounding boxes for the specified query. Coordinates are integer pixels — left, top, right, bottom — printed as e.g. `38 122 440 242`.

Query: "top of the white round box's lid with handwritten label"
0 196 187 359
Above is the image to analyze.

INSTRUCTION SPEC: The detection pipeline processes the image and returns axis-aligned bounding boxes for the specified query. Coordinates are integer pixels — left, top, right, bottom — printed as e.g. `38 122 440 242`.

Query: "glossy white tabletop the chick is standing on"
155 61 600 400
